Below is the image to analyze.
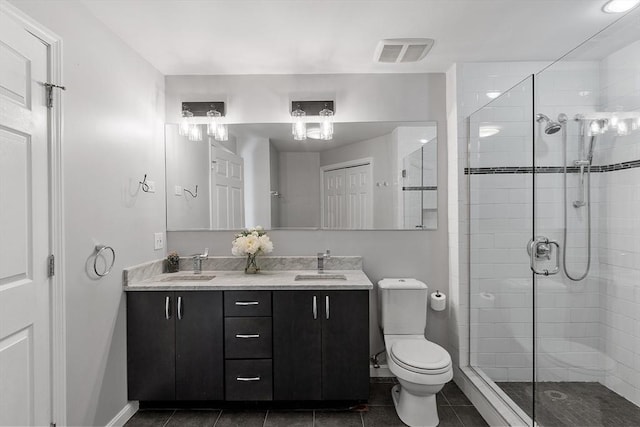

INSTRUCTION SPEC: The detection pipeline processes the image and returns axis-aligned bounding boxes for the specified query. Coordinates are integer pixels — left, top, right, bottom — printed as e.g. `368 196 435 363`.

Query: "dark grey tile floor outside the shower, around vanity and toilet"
125 382 488 427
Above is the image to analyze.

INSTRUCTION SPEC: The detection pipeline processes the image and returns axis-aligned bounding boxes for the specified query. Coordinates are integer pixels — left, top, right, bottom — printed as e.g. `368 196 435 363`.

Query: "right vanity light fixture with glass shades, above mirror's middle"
291 101 335 141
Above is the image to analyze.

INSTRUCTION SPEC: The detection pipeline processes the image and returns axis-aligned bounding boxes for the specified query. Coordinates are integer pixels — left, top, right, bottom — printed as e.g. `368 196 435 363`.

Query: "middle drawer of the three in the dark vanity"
224 317 272 359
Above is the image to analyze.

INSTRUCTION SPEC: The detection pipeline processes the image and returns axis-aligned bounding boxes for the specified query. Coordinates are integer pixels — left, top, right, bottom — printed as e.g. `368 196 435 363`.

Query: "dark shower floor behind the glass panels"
497 382 640 427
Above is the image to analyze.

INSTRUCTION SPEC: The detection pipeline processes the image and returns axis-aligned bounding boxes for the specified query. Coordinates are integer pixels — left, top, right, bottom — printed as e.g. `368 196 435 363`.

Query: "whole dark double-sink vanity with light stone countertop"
124 260 373 403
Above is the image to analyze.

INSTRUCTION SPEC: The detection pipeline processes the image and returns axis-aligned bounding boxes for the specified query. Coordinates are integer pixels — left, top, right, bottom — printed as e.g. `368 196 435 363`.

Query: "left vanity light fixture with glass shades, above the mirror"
179 102 229 141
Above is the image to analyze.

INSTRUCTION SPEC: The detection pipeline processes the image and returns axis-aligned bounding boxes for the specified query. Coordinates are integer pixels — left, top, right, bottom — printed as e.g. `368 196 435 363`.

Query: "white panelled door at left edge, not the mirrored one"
0 8 51 426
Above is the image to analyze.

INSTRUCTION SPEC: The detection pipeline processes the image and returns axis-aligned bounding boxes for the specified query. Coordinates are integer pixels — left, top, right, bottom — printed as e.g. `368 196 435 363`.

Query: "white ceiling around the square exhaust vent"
82 0 632 75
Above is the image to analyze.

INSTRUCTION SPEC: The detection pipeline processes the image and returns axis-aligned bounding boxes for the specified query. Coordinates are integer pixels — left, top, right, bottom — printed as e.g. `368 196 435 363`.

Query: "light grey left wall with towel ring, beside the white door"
13 0 165 426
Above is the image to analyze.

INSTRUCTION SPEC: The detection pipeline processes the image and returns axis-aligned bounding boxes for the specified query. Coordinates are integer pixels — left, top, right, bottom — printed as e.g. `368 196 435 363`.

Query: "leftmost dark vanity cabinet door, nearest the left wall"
127 292 175 400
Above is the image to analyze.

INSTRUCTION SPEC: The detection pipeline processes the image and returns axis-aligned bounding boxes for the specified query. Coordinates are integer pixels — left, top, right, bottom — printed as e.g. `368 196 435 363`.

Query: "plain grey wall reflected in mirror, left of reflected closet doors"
278 152 321 228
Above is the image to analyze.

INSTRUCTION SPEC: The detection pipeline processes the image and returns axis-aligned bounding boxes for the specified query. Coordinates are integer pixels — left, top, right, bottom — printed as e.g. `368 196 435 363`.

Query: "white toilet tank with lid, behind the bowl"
378 279 429 335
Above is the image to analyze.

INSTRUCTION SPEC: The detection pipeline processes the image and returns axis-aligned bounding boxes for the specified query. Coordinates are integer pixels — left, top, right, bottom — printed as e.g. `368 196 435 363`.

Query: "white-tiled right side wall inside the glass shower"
595 42 640 405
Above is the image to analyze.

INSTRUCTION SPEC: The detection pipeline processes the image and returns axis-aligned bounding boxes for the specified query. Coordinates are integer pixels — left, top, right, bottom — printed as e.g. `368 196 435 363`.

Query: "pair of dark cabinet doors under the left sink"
127 291 224 401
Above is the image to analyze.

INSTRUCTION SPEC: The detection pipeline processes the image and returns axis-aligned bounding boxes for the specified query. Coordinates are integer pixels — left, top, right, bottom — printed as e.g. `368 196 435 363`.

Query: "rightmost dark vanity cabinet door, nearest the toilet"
321 290 369 400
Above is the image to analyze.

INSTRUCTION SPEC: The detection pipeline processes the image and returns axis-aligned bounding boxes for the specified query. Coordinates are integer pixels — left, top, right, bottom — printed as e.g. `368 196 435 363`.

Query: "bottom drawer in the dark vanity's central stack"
225 359 273 400
